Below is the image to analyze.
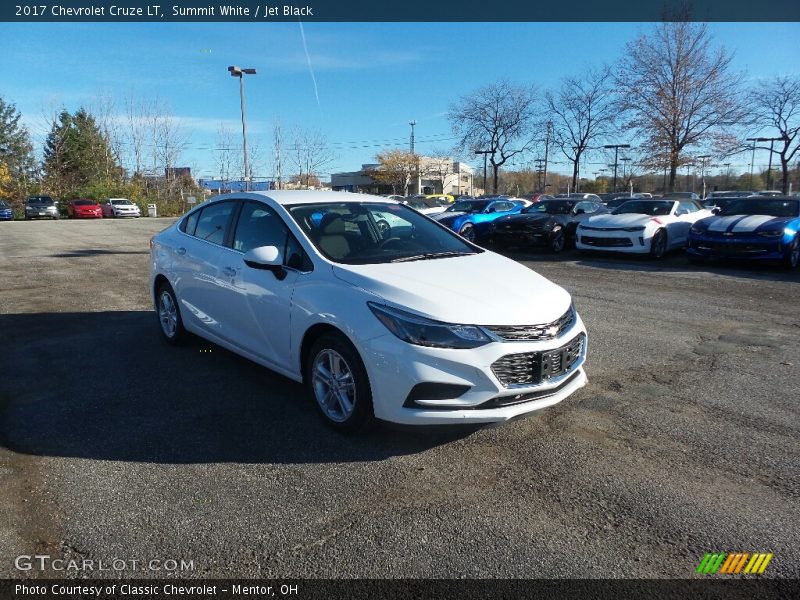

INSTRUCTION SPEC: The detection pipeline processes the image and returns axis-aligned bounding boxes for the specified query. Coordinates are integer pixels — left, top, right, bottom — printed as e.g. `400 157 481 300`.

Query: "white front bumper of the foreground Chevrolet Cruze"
359 317 587 425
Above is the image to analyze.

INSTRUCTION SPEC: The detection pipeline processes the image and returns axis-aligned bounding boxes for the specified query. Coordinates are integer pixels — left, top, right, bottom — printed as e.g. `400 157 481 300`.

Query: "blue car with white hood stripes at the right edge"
686 196 800 269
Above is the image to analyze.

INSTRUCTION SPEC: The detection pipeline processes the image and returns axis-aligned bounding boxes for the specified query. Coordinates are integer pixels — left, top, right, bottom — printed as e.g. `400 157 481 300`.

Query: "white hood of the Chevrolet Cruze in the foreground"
333 251 571 325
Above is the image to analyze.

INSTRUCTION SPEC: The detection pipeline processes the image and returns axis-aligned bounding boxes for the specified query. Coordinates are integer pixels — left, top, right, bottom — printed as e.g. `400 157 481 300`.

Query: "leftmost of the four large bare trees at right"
448 80 537 193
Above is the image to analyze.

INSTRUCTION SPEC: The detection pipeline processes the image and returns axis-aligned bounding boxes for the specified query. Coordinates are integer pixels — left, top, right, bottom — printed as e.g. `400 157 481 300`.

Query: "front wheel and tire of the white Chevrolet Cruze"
305 333 375 433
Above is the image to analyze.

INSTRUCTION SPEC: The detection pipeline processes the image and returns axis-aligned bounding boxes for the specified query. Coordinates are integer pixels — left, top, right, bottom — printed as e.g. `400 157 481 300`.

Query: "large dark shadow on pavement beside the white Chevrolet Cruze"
0 311 474 464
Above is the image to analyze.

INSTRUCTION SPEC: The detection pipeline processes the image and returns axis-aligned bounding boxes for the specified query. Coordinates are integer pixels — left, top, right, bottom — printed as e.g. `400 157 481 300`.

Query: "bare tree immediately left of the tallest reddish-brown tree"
545 67 616 189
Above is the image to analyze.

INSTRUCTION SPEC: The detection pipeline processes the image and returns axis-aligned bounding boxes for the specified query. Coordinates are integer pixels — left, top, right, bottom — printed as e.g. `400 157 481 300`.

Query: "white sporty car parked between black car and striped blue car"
575 199 712 258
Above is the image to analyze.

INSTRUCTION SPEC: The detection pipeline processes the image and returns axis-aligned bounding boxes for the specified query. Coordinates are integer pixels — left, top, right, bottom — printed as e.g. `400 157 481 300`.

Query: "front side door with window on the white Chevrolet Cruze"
214 200 310 369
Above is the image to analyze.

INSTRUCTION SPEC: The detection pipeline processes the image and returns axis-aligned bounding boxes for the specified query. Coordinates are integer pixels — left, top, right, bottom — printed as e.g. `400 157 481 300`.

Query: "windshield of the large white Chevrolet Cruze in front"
286 202 482 265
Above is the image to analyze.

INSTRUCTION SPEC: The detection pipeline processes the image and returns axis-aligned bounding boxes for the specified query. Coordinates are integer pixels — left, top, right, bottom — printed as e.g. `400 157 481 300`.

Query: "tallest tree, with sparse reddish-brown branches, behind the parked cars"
615 21 747 191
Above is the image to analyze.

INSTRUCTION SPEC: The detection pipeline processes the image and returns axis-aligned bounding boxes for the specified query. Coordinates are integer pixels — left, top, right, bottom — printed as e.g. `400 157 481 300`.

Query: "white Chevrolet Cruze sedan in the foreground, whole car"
150 191 586 430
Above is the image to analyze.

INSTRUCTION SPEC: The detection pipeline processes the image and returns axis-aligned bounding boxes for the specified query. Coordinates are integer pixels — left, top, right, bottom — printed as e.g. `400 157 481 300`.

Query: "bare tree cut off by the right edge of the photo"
748 76 800 194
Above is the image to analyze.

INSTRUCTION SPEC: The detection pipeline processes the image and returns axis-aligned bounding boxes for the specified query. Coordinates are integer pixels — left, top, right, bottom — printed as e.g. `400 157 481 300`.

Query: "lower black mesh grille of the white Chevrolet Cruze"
492 333 586 387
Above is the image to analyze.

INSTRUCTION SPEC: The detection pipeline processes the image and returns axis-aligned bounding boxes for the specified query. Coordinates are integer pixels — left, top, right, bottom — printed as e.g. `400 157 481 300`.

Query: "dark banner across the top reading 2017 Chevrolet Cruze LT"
0 0 800 22
